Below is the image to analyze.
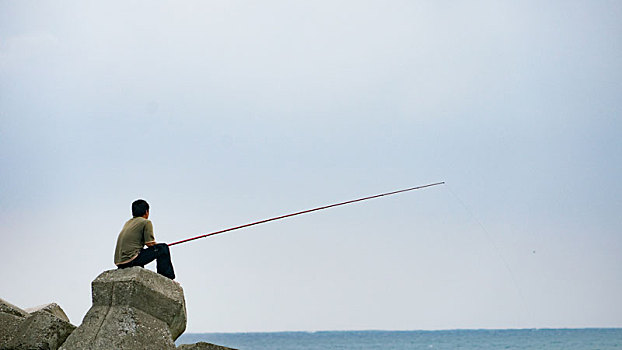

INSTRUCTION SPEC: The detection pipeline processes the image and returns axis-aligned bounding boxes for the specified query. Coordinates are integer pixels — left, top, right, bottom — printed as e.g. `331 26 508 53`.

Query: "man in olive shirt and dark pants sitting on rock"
114 199 175 279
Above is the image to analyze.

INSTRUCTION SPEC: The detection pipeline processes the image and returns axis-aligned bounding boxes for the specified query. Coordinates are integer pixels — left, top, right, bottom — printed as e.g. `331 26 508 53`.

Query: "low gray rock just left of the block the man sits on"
6 311 76 350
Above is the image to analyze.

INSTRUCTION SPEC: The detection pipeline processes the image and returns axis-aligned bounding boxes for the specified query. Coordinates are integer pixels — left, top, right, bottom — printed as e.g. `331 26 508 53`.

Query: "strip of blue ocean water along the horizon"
177 328 622 350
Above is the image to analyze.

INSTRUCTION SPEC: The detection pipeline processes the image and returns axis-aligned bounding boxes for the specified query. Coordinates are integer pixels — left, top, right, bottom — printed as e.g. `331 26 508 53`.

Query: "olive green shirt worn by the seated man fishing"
114 216 155 265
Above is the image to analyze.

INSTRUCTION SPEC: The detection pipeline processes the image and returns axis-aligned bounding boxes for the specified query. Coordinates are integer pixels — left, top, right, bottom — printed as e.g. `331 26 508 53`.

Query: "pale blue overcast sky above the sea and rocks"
0 0 622 332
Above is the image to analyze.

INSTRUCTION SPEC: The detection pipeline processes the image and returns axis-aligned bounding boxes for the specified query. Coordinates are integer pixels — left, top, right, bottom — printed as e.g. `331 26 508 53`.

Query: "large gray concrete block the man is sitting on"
61 267 186 350
